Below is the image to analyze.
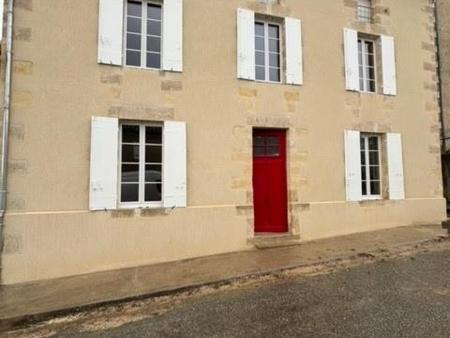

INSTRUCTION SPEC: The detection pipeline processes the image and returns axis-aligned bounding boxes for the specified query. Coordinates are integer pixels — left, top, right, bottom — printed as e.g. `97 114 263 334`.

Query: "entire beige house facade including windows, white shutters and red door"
1 0 445 284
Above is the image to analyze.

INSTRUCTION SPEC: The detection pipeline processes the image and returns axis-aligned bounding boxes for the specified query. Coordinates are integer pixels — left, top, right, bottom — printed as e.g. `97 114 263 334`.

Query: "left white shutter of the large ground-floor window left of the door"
89 117 119 210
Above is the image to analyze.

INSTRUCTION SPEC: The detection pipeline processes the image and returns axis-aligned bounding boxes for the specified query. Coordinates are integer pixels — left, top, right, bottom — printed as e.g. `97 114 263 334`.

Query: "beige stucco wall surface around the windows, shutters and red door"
2 0 445 284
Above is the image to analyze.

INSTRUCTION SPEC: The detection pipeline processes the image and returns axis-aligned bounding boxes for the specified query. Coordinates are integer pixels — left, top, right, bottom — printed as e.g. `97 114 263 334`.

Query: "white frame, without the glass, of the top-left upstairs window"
123 0 164 71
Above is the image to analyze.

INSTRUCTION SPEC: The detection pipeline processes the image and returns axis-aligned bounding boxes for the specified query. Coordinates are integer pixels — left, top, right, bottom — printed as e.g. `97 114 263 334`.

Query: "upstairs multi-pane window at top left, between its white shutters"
125 0 162 69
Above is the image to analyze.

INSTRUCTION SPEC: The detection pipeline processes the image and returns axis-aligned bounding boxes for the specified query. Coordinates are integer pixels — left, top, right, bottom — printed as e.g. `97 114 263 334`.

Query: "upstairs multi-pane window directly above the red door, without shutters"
255 22 281 82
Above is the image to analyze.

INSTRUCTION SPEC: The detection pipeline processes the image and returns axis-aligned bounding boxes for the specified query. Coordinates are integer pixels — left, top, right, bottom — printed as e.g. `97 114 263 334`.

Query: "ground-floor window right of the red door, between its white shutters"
361 134 381 199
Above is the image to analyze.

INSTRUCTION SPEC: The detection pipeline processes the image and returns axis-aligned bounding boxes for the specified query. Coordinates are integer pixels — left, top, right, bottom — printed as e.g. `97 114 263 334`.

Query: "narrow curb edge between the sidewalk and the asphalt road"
0 235 450 333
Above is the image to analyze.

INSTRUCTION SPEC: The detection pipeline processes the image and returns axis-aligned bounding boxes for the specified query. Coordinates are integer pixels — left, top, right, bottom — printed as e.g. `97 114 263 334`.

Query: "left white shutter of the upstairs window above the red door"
237 8 255 80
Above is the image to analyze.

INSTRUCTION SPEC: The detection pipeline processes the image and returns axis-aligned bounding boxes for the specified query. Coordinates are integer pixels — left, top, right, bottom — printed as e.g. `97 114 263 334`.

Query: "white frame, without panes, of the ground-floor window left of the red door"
117 121 164 209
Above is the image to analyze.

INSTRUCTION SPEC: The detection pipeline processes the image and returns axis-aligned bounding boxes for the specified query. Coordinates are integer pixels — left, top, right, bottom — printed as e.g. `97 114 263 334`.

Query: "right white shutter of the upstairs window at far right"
381 35 397 95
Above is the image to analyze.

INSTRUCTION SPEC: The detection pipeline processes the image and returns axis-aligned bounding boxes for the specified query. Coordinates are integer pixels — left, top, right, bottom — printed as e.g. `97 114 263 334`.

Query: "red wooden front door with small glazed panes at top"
253 129 288 232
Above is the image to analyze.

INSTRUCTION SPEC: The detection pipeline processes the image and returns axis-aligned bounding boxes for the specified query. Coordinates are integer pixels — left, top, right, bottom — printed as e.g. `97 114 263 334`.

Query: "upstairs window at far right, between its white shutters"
358 39 376 93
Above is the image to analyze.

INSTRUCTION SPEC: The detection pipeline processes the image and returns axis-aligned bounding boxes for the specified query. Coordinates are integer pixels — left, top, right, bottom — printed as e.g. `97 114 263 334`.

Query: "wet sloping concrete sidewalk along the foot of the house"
0 225 447 331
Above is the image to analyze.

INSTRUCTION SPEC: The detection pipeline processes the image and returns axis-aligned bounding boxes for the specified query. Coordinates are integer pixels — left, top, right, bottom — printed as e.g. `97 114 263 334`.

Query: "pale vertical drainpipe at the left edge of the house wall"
0 0 14 264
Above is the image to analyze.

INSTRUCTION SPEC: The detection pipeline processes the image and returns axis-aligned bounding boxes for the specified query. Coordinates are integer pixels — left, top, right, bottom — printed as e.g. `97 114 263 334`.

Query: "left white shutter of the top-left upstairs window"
98 0 124 66
